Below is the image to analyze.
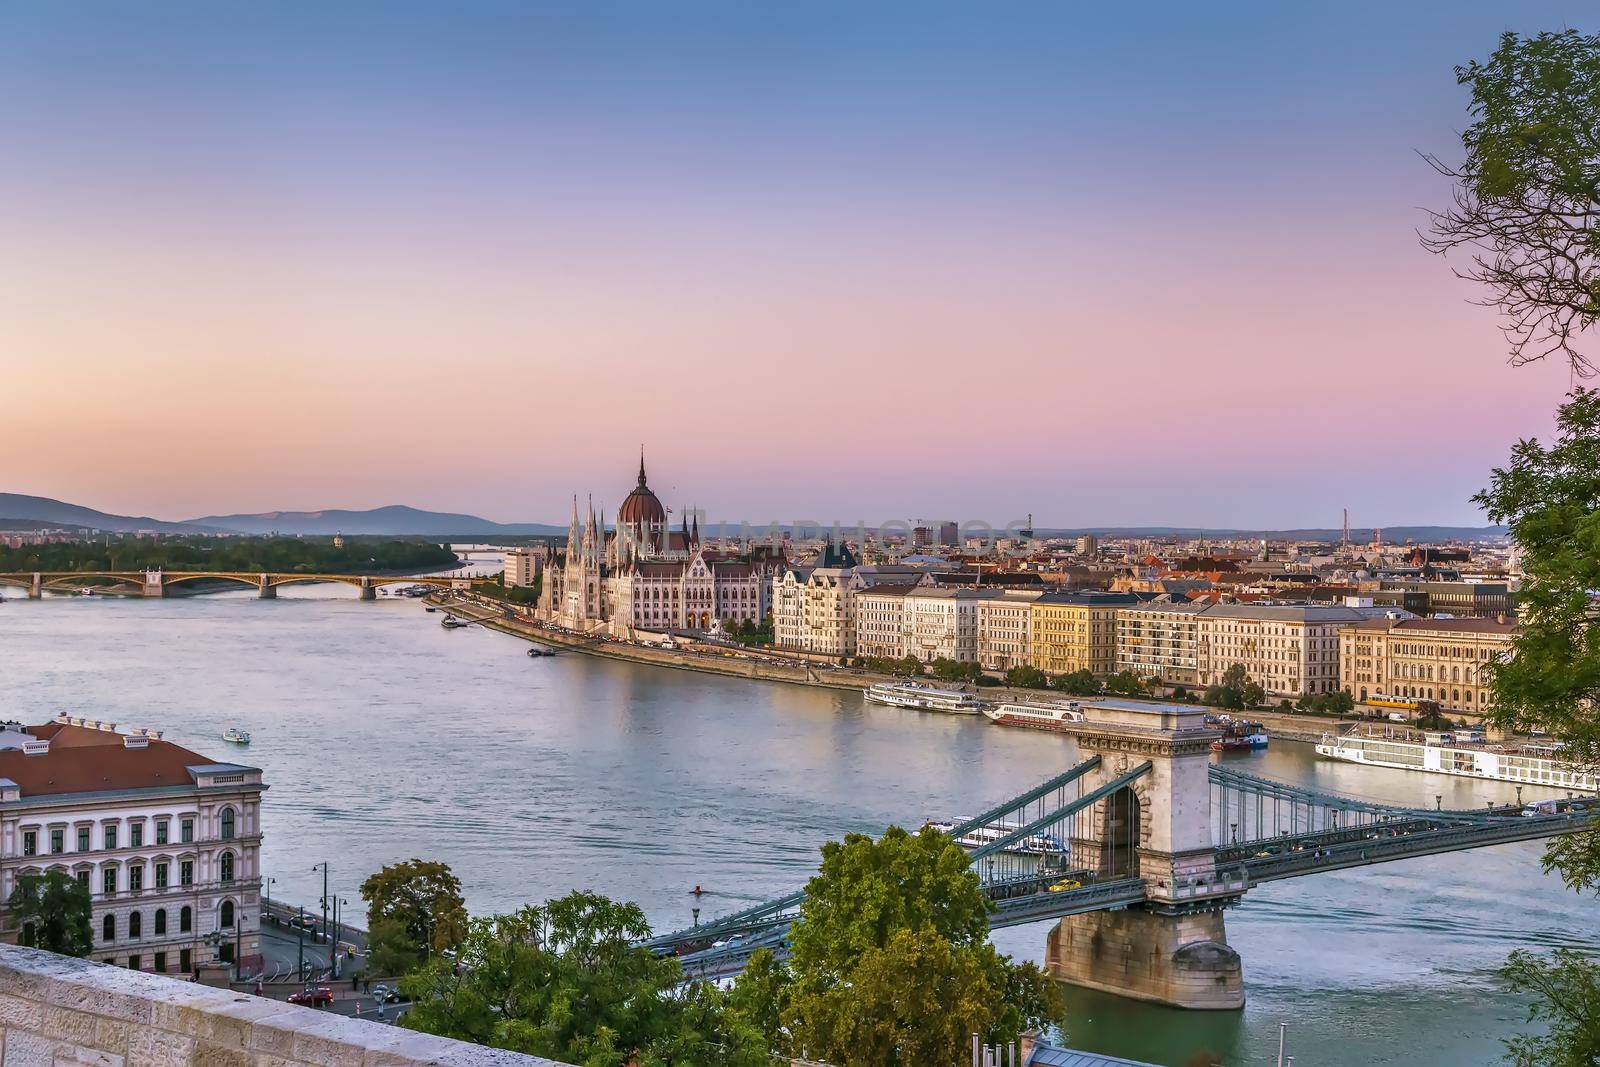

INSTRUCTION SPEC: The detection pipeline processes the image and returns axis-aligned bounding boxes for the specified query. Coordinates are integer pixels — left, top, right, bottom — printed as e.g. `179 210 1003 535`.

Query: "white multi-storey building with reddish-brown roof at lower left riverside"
0 715 267 976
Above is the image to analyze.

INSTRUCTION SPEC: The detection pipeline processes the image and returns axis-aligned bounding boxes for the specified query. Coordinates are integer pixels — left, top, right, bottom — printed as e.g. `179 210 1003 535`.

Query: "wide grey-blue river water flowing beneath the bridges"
0 587 1595 1067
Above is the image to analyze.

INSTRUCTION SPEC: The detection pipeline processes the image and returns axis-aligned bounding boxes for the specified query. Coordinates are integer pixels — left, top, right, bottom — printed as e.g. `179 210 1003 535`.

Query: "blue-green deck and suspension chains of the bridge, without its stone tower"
646 758 1600 979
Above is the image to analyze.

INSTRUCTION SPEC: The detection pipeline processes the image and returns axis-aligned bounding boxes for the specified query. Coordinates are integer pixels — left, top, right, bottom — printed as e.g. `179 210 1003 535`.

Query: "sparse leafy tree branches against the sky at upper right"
1424 30 1600 376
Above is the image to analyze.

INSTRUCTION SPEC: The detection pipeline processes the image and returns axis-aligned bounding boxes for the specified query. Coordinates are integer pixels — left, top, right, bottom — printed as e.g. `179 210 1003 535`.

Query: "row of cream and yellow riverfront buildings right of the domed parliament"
773 566 1515 712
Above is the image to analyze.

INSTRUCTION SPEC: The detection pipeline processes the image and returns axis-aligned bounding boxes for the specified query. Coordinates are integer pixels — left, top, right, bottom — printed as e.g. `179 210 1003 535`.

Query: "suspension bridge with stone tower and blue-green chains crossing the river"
646 701 1600 1008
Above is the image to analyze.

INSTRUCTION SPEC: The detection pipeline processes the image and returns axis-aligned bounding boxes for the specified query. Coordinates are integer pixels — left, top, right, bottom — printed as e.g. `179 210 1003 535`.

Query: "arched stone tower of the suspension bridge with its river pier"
1046 701 1245 1009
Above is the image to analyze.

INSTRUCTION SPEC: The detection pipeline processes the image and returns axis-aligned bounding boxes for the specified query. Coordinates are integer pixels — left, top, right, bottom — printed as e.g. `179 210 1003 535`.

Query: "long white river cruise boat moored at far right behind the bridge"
1317 726 1600 793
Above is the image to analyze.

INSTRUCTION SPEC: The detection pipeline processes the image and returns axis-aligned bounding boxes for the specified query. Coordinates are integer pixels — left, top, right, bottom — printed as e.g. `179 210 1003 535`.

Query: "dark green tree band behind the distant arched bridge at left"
0 537 456 574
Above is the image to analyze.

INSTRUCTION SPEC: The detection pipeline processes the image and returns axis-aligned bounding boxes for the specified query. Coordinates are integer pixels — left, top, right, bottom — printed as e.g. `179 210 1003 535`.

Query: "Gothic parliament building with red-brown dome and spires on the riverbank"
539 454 786 637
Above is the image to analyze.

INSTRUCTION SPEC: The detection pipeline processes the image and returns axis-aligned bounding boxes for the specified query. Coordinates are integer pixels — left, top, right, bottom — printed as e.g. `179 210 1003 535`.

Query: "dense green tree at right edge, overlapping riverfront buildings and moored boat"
1475 389 1600 889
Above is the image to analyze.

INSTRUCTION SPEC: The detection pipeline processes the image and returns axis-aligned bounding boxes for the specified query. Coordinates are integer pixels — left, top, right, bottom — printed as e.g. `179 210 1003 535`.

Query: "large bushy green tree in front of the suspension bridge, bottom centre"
734 827 1062 1067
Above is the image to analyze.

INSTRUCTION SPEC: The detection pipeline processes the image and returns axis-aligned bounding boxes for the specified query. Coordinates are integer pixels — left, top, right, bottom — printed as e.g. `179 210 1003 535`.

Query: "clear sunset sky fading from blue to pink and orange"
0 0 1597 528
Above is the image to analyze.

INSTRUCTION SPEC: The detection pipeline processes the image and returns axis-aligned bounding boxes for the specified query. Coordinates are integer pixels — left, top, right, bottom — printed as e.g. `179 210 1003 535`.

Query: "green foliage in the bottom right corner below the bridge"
1501 949 1600 1067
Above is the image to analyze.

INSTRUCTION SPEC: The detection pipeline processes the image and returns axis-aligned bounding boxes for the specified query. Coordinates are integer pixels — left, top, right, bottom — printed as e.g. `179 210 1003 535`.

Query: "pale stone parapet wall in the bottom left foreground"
0 945 562 1067
